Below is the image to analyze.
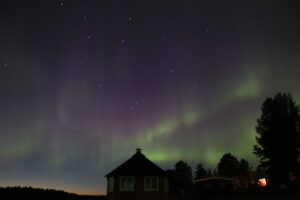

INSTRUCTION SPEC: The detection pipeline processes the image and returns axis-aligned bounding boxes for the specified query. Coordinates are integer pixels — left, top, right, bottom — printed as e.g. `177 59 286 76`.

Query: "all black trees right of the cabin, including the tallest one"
167 93 300 199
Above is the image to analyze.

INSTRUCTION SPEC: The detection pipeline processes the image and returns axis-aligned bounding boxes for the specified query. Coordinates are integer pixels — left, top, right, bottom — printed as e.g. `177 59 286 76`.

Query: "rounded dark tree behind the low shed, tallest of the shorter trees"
218 153 240 178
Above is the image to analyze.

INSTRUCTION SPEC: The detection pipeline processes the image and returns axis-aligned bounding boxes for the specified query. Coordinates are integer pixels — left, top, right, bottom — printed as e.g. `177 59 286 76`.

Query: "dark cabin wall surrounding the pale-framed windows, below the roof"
107 176 169 200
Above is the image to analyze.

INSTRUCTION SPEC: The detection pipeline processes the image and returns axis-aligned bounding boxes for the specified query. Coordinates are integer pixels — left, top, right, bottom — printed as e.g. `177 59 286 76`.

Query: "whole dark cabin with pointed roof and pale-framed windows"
106 149 170 200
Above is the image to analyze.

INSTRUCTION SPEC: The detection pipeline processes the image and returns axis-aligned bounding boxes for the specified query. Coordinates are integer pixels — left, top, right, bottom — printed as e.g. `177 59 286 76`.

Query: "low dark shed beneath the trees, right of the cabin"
195 177 235 197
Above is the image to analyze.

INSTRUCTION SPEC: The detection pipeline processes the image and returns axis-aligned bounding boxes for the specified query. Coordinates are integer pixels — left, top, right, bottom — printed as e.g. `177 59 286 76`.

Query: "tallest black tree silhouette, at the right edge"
253 93 300 184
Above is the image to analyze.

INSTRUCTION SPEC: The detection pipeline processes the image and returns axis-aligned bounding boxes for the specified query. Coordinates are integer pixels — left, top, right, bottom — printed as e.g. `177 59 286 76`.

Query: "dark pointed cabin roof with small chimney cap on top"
106 149 165 177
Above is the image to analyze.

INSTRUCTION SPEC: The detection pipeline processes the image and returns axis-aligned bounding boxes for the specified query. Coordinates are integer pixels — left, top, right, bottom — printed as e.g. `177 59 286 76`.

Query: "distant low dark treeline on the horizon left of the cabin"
0 187 105 200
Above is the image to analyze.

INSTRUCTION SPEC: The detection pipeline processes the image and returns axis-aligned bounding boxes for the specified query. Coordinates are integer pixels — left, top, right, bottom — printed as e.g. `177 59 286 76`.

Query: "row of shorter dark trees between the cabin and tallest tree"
166 153 256 199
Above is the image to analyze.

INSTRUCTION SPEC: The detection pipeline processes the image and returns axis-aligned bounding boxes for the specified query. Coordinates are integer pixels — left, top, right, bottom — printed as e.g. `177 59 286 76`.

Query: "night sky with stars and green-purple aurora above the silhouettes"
0 0 300 194
